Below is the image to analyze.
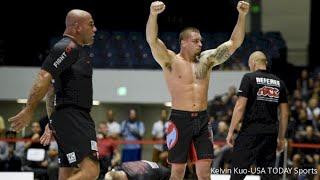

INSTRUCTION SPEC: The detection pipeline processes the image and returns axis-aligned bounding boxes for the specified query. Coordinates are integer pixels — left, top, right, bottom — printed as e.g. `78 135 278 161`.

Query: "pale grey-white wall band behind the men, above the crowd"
0 67 245 103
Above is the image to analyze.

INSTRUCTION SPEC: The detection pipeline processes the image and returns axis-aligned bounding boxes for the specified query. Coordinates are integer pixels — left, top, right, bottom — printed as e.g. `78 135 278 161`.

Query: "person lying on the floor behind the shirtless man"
105 160 170 180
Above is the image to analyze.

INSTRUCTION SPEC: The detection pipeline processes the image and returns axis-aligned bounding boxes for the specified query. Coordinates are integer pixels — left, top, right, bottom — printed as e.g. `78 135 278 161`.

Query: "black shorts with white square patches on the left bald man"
50 106 98 167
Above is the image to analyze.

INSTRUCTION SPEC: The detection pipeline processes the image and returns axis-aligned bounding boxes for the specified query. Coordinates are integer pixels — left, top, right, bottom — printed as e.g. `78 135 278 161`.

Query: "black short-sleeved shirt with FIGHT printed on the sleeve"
42 36 93 109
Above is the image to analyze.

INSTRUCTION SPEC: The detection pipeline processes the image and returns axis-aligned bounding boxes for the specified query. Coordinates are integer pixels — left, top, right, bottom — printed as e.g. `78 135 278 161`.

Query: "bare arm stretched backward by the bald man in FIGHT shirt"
9 70 52 132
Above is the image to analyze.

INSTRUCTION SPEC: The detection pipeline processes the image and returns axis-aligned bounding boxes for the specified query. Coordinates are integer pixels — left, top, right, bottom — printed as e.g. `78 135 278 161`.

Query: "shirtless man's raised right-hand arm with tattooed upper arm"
201 1 250 67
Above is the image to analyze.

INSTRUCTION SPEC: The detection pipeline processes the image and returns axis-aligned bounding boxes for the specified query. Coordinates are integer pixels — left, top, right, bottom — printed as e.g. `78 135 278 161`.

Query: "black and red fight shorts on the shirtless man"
166 109 213 163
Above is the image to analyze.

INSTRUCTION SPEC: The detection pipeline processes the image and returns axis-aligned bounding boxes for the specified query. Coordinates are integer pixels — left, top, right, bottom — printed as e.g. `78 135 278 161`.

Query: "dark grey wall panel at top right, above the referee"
262 0 310 65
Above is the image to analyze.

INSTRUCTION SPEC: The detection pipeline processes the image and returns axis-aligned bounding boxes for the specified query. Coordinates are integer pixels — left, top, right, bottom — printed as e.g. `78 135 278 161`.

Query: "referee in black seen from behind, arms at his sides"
227 51 288 180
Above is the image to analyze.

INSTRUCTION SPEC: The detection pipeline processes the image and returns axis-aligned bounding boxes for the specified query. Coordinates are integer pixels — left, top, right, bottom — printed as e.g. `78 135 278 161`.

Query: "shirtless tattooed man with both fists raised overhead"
146 1 249 180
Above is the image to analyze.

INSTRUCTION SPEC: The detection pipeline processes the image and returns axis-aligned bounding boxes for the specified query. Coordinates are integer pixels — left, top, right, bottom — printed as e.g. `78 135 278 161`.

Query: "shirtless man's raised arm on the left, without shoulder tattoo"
146 1 174 68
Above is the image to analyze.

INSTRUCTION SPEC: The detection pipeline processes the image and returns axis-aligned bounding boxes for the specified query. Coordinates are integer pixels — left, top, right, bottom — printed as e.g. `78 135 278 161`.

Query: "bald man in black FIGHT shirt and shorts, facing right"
9 9 99 180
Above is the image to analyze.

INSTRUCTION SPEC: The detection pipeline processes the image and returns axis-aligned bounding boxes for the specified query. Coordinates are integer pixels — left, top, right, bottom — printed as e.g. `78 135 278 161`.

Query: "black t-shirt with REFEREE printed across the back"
238 70 288 135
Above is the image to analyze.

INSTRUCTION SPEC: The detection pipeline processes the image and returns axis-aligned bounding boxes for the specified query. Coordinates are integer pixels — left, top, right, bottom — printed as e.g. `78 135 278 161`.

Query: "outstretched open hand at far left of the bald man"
8 108 33 132
